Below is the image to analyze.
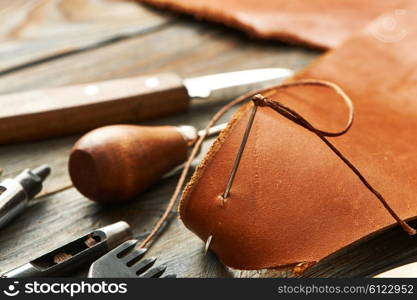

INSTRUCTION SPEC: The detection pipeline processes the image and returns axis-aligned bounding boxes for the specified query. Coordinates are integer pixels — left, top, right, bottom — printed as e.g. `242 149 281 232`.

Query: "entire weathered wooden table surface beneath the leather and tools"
0 0 416 277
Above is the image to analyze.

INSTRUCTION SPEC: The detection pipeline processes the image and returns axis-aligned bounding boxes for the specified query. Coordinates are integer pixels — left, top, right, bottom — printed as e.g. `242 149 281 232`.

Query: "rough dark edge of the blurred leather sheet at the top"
138 0 332 50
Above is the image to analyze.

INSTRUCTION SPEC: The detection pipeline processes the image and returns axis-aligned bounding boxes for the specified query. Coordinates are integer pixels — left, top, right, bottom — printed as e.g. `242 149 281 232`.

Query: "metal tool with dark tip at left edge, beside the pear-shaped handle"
0 165 51 228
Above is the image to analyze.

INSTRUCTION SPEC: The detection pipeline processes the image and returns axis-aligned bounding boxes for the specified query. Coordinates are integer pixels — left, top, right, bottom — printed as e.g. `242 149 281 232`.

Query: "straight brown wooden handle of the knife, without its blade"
0 74 189 144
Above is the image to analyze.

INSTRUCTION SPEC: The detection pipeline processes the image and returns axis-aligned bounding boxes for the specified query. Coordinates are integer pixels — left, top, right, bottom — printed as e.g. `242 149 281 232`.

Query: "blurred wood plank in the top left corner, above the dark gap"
0 0 172 74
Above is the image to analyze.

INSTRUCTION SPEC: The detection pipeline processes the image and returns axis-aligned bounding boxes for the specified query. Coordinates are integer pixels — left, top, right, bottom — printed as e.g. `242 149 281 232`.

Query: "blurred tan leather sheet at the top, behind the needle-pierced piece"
139 0 409 48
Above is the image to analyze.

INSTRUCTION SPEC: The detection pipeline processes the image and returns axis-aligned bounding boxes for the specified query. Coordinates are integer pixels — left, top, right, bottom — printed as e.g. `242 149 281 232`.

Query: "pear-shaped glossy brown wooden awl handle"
69 125 188 204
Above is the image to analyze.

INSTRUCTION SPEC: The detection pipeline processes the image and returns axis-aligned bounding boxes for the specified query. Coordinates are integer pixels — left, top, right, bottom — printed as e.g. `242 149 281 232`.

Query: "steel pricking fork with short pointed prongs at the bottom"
88 240 166 278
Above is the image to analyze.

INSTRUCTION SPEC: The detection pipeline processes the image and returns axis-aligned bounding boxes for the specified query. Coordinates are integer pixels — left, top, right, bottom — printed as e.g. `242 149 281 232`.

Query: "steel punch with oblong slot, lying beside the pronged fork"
1 221 132 278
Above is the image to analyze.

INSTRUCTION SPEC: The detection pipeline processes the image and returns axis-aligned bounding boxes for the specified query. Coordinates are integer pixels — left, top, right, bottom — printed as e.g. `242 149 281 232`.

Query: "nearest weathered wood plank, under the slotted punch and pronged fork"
0 170 417 277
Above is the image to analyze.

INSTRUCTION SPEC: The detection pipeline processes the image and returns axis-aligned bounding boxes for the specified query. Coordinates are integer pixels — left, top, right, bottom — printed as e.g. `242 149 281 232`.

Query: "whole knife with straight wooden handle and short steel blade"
0 68 293 144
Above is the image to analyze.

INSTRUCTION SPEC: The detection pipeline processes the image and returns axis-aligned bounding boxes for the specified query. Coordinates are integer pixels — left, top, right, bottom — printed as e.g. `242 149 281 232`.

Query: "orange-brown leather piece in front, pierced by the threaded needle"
180 7 417 269
